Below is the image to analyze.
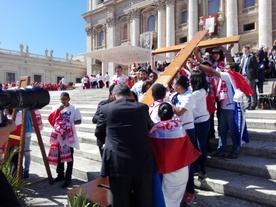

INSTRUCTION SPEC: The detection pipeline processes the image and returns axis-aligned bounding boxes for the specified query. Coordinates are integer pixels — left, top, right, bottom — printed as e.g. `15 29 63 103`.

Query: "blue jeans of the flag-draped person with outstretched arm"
218 109 240 155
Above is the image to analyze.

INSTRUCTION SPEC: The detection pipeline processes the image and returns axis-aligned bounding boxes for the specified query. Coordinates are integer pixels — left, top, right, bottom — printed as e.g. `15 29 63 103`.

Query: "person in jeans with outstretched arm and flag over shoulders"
190 58 253 159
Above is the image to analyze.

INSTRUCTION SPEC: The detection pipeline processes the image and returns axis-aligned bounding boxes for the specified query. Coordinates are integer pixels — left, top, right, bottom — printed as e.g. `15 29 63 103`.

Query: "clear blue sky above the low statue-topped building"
0 0 87 58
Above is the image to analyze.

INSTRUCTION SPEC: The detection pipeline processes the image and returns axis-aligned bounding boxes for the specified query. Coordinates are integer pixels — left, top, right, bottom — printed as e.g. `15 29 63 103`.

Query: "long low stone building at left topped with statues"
0 46 87 84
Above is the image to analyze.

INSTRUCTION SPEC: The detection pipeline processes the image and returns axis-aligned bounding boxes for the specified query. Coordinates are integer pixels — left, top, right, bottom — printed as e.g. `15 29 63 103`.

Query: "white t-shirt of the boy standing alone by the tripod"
52 104 82 149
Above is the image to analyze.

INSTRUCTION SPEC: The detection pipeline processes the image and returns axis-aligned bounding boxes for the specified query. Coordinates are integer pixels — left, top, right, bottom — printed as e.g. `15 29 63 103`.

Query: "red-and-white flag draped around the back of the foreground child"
149 119 200 174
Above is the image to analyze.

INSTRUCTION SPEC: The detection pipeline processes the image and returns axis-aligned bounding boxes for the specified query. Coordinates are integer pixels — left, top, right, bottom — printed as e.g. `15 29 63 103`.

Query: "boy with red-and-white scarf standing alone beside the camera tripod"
48 92 82 188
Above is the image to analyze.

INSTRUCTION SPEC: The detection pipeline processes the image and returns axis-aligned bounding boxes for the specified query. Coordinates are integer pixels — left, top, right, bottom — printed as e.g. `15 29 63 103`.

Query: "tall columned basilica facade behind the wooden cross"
82 0 276 77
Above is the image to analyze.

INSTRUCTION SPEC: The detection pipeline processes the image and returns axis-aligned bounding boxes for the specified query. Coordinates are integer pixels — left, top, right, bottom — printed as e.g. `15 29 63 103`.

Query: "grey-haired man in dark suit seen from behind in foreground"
95 84 157 207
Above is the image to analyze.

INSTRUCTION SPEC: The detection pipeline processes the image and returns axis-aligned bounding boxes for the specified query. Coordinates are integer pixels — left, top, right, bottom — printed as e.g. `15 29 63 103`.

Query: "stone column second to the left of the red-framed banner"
166 0 175 60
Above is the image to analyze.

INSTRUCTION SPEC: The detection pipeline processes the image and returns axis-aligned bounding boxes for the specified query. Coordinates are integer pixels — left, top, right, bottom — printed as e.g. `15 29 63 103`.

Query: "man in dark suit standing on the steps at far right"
240 45 258 110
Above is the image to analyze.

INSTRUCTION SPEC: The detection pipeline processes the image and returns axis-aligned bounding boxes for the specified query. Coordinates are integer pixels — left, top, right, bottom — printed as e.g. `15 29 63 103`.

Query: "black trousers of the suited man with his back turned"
109 173 153 207
